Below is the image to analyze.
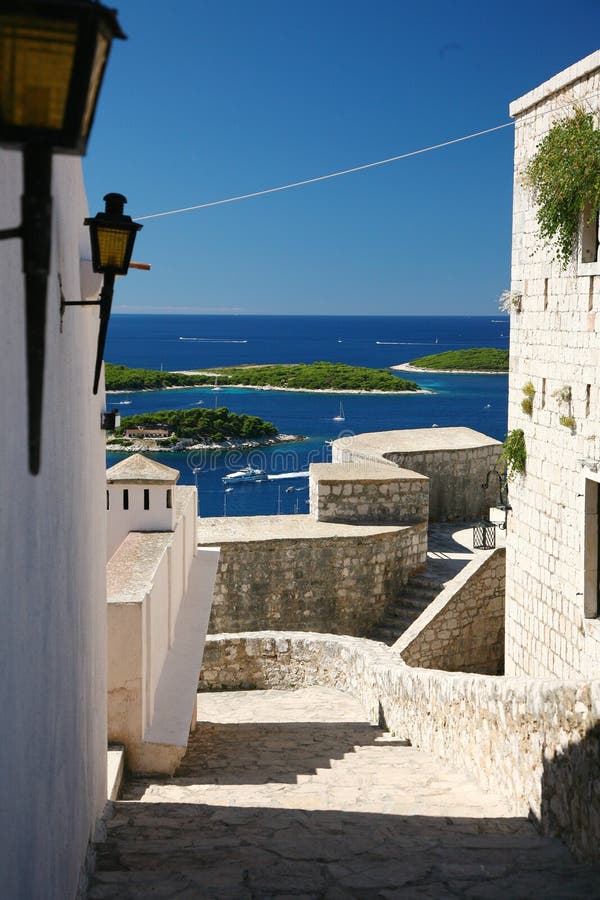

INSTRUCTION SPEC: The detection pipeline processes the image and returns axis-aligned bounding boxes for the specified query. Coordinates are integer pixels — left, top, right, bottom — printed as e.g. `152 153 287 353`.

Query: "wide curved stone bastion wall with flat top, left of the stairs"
199 516 427 635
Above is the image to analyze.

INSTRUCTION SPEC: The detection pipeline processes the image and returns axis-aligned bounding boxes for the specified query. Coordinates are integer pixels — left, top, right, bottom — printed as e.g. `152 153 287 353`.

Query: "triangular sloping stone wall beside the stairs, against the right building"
392 547 506 675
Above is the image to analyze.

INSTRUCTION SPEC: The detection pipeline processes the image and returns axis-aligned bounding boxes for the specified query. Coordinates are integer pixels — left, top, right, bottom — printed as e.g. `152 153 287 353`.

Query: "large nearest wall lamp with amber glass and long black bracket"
0 0 125 475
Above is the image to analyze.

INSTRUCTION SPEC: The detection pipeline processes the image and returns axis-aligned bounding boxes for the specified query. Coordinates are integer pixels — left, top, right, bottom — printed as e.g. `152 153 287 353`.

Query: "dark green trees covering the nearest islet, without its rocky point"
111 406 279 446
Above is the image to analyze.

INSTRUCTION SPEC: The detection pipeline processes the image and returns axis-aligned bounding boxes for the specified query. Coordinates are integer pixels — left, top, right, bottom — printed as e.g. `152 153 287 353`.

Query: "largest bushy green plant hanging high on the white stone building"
524 107 600 268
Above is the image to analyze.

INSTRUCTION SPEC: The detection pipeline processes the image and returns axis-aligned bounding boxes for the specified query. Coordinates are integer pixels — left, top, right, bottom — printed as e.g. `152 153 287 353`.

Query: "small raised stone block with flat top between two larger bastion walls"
310 463 429 525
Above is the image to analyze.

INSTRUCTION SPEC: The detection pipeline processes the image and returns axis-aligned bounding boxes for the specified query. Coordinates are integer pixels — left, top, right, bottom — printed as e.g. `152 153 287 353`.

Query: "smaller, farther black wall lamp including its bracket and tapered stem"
61 194 143 394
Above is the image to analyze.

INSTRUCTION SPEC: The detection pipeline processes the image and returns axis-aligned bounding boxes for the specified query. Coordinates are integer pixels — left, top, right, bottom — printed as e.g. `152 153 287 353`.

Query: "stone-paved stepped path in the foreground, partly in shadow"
89 688 600 900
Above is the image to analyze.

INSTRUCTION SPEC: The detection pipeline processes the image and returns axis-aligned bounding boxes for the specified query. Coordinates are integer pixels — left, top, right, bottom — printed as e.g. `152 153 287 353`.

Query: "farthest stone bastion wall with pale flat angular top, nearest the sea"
332 428 502 522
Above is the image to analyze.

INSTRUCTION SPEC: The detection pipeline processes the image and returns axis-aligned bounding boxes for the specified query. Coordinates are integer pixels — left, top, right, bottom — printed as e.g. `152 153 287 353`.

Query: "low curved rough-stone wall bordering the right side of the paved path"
199 632 600 860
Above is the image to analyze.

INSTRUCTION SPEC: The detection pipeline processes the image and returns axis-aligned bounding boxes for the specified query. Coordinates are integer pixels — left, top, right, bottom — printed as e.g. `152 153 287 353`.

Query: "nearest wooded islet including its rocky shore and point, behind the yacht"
108 407 286 451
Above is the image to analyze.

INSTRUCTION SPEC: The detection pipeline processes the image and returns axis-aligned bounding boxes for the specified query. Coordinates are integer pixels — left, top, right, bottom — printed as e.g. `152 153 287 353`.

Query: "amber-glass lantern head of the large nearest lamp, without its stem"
0 0 125 155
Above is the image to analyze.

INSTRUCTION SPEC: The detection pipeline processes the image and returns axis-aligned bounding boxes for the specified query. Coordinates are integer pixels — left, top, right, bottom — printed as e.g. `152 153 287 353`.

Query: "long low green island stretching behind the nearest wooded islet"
105 362 420 393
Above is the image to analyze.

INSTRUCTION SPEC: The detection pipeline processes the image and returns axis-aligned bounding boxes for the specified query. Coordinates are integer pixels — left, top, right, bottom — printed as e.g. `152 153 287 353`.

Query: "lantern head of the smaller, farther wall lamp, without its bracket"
83 194 143 275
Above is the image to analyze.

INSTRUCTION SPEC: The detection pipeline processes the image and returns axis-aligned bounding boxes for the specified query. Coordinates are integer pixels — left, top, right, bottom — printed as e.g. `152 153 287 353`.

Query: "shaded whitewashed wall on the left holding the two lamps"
0 151 106 900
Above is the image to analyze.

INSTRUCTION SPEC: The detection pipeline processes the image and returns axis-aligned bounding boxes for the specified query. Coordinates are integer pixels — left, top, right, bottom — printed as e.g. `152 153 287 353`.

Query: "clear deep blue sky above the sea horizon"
84 0 600 315
